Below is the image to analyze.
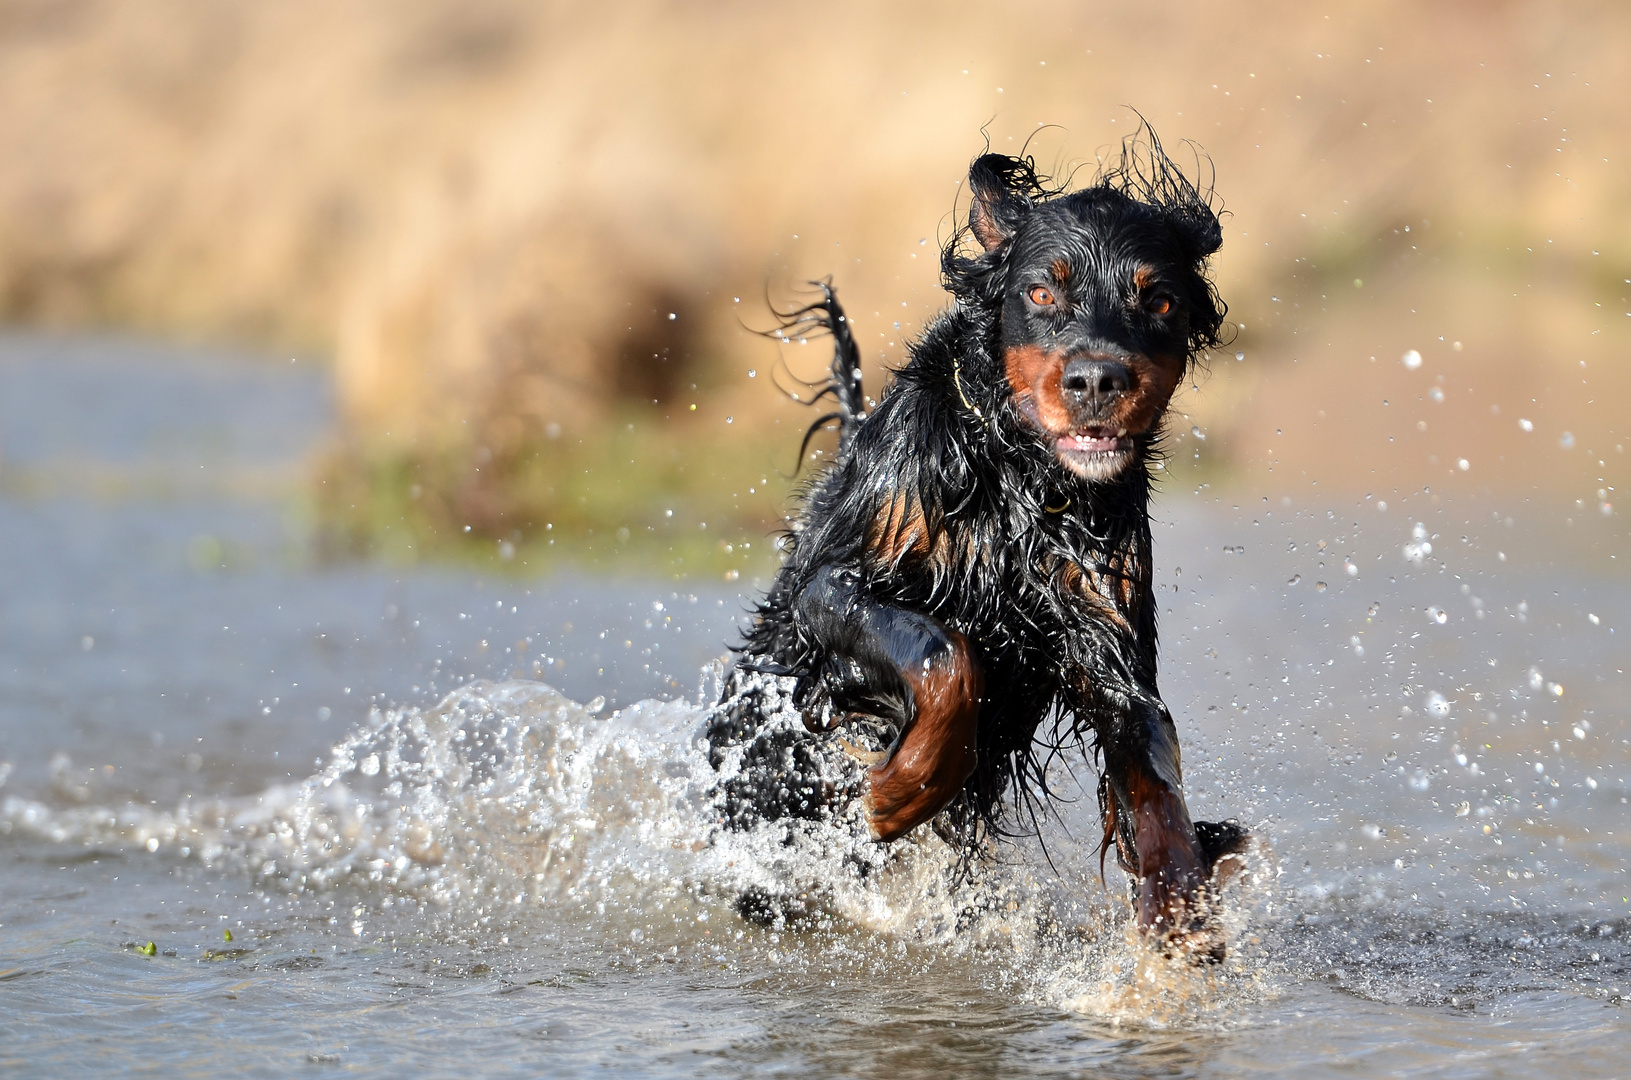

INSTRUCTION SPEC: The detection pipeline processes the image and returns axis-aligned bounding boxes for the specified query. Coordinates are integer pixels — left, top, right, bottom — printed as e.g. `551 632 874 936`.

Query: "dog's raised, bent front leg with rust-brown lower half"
794 566 983 842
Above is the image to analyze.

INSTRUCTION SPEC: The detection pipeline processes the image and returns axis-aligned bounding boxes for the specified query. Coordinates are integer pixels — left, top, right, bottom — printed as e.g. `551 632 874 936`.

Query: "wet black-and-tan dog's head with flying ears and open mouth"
954 134 1225 481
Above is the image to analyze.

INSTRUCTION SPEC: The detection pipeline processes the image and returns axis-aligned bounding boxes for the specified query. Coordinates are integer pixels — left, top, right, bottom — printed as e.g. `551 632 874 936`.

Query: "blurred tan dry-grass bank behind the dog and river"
0 0 1631 579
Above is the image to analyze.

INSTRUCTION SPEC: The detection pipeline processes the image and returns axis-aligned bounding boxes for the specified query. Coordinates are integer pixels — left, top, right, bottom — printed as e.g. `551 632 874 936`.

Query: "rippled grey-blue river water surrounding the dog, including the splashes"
0 336 1631 1080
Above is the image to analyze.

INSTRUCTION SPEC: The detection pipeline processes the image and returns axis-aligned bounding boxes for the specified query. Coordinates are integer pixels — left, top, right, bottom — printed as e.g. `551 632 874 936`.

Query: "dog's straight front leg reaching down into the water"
1101 700 1207 936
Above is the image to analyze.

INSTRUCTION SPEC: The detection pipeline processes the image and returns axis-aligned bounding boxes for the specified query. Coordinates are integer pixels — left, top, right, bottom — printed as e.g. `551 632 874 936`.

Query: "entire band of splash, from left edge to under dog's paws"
0 682 1272 1025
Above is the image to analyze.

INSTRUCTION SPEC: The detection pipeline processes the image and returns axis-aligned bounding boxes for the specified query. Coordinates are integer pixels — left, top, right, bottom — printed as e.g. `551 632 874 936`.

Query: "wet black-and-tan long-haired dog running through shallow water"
708 131 1246 936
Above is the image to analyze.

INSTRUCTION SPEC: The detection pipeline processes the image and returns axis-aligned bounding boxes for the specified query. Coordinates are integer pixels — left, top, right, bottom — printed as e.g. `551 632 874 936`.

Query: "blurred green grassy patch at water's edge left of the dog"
315 406 793 579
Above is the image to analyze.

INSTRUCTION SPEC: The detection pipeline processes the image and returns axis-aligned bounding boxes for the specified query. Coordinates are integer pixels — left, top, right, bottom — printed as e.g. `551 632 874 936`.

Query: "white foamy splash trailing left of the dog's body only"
0 682 706 907
